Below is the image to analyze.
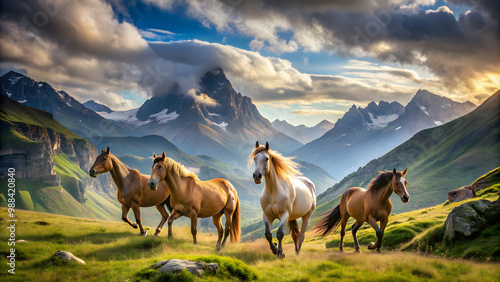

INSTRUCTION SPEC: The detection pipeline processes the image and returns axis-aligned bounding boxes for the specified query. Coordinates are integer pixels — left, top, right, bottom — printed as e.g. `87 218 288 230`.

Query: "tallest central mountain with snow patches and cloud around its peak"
95 68 302 167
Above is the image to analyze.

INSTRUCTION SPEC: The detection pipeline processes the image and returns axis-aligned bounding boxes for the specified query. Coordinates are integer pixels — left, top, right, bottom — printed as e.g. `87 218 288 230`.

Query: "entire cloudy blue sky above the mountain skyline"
0 0 500 125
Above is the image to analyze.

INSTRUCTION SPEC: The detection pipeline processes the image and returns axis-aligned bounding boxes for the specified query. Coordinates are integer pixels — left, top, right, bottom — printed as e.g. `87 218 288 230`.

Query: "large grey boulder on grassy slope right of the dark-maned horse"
444 200 492 239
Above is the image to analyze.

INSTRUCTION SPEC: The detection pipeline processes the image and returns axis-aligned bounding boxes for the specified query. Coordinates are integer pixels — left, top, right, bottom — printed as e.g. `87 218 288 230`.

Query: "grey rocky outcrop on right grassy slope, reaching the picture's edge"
444 200 500 241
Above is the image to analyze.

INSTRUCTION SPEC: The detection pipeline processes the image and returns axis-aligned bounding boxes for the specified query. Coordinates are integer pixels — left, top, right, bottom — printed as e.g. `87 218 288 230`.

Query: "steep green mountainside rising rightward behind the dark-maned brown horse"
318 91 500 213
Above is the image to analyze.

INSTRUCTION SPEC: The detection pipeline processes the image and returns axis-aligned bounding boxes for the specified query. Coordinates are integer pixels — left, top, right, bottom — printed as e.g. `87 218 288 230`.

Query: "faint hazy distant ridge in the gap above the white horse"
271 119 334 144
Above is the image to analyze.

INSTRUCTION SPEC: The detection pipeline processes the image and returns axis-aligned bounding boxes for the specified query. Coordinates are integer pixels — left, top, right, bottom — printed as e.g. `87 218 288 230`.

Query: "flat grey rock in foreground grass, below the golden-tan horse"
153 259 220 276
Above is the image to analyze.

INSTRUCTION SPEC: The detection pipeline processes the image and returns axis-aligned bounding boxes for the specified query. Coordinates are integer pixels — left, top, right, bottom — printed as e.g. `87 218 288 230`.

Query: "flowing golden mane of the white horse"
248 145 302 179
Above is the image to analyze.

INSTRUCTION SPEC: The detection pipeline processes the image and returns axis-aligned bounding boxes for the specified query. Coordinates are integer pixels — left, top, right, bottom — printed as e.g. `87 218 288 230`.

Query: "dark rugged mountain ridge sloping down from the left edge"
0 71 133 140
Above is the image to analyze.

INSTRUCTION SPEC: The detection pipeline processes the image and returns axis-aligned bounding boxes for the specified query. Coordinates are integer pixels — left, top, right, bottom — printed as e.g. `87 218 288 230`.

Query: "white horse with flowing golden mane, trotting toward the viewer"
249 141 316 258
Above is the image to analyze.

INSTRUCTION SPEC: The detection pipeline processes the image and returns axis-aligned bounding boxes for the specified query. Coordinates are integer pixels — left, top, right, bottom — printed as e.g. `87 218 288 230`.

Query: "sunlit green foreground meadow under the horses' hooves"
0 208 500 281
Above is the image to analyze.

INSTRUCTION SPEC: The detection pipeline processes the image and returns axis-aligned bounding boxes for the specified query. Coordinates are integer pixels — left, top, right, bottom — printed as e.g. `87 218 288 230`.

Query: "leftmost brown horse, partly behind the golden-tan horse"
89 147 170 236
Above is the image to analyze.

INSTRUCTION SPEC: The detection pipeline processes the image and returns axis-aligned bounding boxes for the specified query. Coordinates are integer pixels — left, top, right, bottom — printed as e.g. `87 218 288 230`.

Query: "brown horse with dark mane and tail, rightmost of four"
314 169 410 252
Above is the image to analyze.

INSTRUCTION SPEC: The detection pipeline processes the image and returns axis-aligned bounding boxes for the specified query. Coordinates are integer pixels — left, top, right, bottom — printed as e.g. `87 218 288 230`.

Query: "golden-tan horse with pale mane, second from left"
148 152 240 250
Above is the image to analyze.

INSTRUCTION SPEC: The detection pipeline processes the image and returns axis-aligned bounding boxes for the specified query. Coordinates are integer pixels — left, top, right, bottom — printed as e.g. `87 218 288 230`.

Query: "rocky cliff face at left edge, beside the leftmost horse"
0 123 114 203
